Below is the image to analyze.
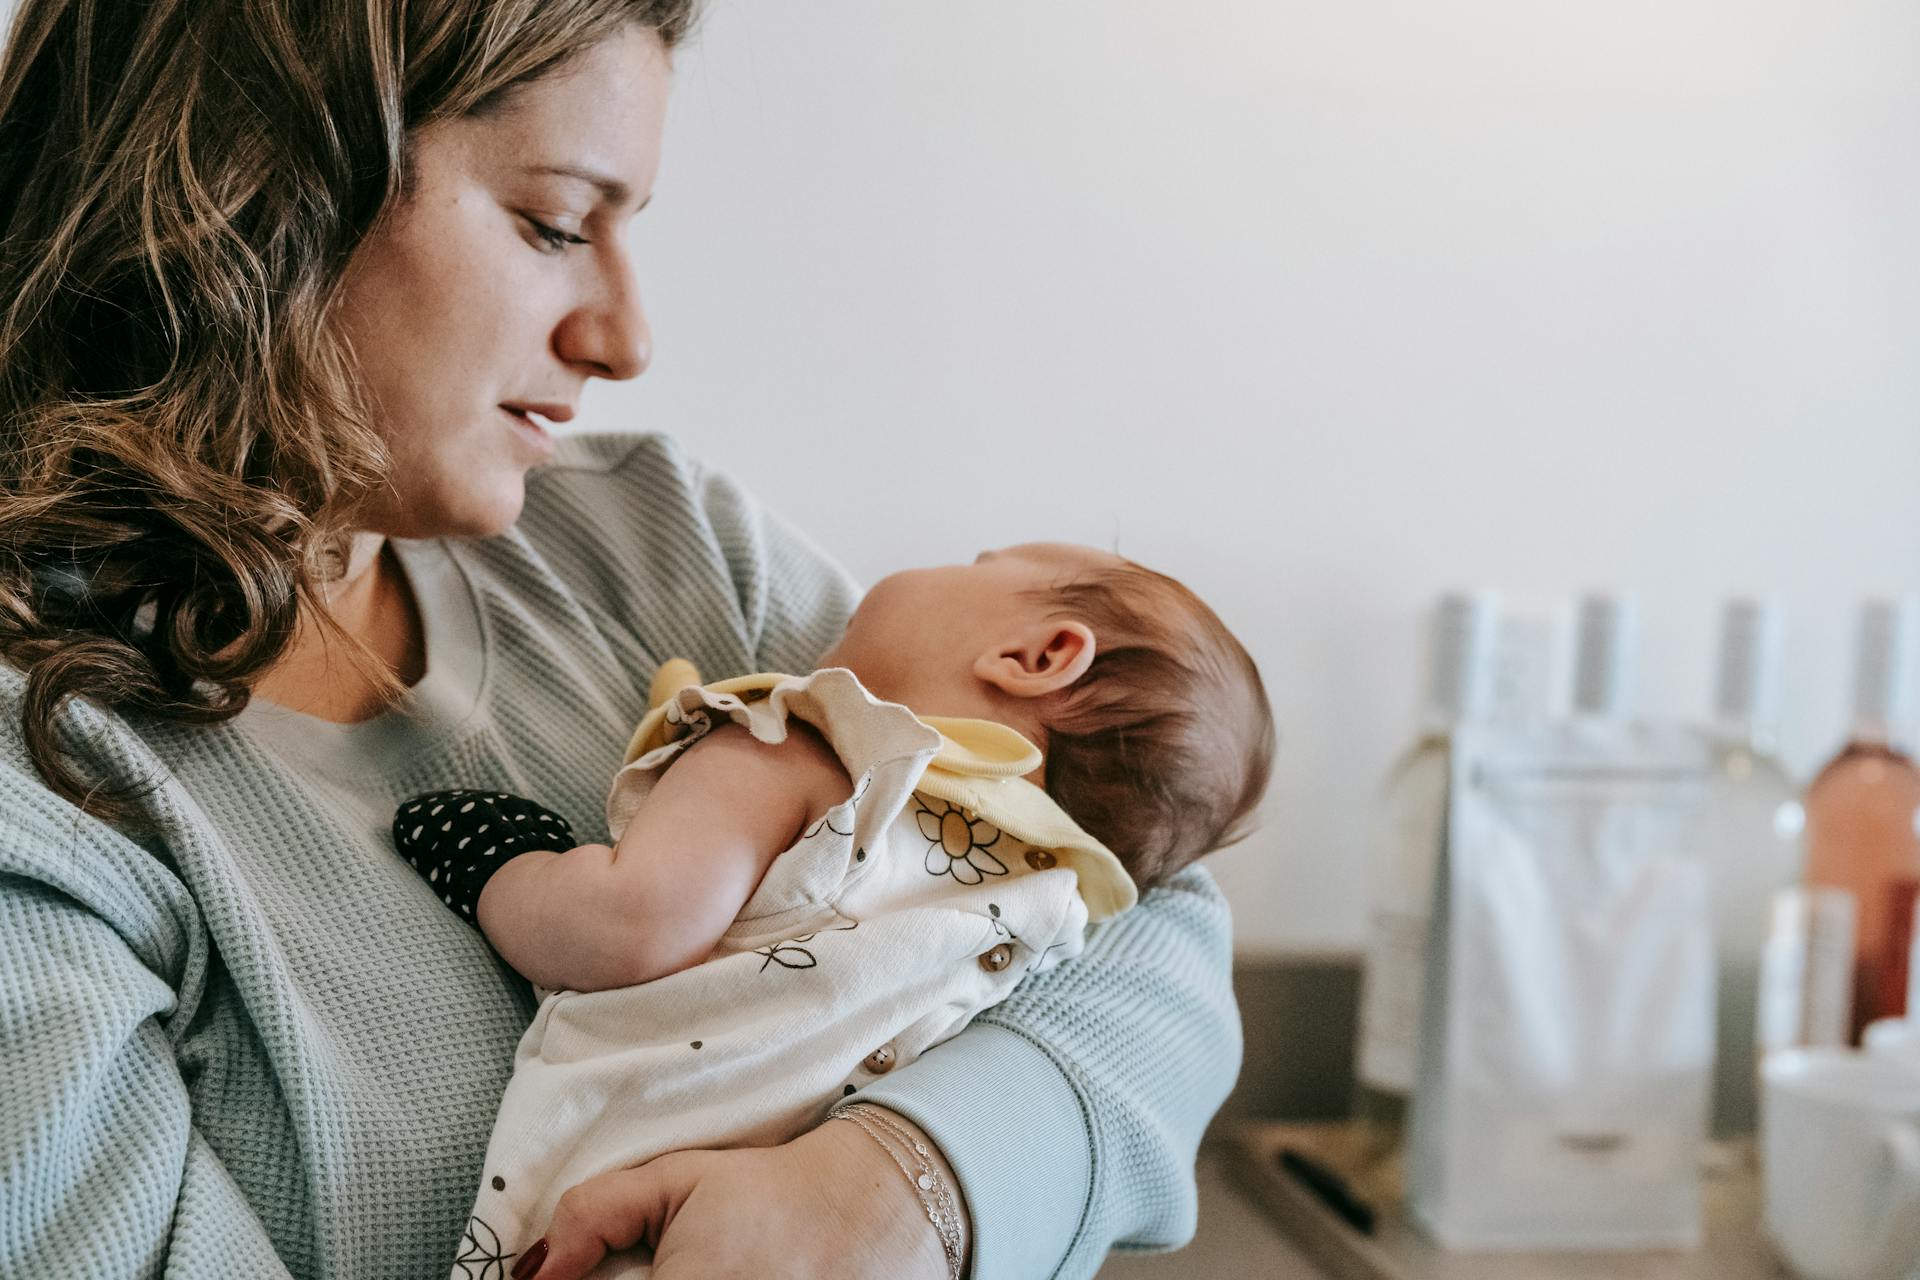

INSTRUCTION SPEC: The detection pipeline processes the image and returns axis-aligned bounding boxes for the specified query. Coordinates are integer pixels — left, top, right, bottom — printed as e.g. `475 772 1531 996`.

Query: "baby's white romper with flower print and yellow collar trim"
451 668 1133 1280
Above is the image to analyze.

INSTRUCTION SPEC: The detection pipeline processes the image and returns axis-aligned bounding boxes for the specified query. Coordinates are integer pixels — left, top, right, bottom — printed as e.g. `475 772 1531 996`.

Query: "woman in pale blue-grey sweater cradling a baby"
0 0 1238 1280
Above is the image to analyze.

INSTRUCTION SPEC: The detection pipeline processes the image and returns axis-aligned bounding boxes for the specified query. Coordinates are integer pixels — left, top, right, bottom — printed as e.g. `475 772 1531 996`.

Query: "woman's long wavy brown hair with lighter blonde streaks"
0 0 695 825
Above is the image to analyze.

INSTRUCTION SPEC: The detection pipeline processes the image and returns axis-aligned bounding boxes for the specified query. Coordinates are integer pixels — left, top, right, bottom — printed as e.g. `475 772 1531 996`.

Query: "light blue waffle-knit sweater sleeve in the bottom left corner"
0 875 288 1280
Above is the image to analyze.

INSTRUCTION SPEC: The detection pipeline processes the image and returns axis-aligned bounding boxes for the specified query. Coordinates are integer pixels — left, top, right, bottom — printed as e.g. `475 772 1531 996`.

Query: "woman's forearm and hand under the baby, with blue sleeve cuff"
538 869 1240 1280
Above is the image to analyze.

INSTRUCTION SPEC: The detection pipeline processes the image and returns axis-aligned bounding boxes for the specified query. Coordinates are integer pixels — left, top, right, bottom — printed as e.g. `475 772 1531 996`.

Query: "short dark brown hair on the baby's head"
1035 562 1275 892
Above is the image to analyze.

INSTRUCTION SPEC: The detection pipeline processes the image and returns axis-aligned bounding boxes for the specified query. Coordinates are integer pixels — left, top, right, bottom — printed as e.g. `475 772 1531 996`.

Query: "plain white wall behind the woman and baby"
602 0 1920 950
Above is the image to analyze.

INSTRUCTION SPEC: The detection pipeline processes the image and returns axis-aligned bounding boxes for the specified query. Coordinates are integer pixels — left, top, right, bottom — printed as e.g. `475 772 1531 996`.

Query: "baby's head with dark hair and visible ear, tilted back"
822 543 1273 890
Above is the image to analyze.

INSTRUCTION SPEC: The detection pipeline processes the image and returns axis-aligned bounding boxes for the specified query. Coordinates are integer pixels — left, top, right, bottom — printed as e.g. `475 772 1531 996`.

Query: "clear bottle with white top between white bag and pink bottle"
1701 599 1807 1138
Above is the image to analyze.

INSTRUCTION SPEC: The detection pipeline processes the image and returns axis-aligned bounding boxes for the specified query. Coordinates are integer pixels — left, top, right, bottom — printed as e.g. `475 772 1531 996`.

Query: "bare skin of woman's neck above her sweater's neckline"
253 533 426 723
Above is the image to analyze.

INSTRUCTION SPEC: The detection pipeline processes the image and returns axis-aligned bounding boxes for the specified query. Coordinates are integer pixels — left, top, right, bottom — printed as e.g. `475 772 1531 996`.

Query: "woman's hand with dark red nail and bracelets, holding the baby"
513 1121 960 1280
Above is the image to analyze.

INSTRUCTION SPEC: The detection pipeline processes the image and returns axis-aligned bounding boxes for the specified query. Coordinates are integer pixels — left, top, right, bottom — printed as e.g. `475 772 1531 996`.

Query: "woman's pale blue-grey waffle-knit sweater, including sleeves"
0 436 1240 1280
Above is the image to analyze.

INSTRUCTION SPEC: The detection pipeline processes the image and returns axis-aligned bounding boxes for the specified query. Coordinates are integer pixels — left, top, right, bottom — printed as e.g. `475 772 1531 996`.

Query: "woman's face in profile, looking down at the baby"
324 27 668 537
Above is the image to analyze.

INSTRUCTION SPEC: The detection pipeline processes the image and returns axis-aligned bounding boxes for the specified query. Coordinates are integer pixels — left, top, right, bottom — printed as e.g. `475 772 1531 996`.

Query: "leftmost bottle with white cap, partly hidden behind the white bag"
1356 593 1500 1155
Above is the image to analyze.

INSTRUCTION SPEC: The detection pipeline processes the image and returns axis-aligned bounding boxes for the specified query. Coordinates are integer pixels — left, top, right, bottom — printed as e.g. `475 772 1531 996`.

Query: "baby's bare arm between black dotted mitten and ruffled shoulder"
474 722 851 990
